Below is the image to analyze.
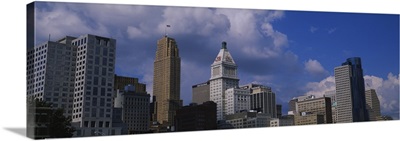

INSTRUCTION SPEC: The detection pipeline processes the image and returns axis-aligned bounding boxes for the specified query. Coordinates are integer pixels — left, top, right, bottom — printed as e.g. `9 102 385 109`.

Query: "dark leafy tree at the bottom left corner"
28 99 76 139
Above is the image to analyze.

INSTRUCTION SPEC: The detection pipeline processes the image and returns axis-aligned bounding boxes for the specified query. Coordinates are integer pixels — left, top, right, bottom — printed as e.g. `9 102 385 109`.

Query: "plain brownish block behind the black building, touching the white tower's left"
192 81 210 104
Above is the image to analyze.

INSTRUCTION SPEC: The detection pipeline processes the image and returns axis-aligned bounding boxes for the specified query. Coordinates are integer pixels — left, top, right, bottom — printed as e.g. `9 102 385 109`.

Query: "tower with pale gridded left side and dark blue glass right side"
335 57 369 123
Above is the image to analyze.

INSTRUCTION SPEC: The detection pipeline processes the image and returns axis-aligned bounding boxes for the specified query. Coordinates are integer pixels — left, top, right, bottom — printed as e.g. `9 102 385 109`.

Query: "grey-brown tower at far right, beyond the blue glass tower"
365 89 381 121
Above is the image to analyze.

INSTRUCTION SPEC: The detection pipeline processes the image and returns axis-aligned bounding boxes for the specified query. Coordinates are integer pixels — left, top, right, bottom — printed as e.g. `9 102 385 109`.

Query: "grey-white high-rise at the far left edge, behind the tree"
26 36 77 116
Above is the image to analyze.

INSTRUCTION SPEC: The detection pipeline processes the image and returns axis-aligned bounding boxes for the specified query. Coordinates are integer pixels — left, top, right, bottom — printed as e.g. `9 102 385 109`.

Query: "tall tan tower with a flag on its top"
153 36 182 125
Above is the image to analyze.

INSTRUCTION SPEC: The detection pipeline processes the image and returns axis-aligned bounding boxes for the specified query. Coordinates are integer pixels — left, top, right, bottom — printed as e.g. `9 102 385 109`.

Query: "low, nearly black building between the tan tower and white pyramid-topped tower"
175 101 217 131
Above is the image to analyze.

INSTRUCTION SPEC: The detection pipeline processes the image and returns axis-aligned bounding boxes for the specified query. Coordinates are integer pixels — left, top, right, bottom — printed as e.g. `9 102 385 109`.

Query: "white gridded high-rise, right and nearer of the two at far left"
71 35 119 136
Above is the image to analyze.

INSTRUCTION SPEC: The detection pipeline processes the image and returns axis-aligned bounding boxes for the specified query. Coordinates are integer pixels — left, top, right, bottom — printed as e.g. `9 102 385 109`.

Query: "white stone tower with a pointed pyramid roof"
210 42 239 120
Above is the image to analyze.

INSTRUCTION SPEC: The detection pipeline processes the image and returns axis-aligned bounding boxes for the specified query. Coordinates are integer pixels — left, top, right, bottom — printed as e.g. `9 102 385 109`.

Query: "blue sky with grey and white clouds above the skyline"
35 3 400 119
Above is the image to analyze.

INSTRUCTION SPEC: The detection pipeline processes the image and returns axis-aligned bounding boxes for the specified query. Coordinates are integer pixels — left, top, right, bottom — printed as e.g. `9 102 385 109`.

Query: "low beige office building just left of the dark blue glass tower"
295 97 332 124
